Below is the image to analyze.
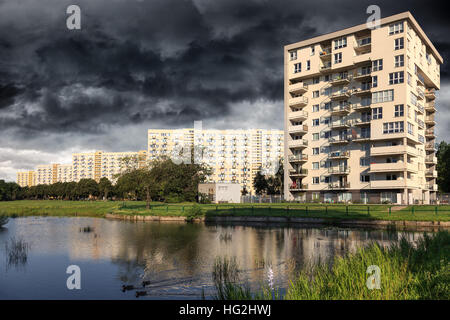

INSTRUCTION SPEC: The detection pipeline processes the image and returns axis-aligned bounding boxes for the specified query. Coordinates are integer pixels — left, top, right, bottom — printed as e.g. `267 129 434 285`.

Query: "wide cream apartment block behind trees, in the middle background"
148 128 284 194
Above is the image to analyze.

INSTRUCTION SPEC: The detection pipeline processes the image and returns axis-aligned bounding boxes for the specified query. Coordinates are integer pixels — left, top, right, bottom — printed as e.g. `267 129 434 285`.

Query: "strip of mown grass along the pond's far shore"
0 200 450 221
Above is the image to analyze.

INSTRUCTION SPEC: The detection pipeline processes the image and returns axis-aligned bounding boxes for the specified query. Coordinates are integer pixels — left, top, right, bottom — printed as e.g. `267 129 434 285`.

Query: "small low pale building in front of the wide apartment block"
198 183 241 203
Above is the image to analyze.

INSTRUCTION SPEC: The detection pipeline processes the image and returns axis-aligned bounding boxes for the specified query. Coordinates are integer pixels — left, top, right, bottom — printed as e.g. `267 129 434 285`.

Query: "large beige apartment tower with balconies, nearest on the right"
284 12 443 204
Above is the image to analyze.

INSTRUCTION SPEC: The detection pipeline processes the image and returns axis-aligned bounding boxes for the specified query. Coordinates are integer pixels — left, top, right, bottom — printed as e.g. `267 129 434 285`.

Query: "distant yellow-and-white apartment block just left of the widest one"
72 150 147 183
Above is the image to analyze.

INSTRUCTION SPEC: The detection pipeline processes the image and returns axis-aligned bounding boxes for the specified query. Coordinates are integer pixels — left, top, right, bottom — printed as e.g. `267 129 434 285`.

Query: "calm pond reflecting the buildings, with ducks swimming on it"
0 217 428 299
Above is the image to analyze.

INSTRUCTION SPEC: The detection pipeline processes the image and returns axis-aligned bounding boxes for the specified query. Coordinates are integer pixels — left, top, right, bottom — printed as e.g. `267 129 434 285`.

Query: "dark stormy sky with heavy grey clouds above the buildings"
0 0 450 181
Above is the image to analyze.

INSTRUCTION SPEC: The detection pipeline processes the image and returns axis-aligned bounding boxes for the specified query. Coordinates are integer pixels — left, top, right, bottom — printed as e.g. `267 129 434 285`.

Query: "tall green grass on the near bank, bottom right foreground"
213 231 450 300
